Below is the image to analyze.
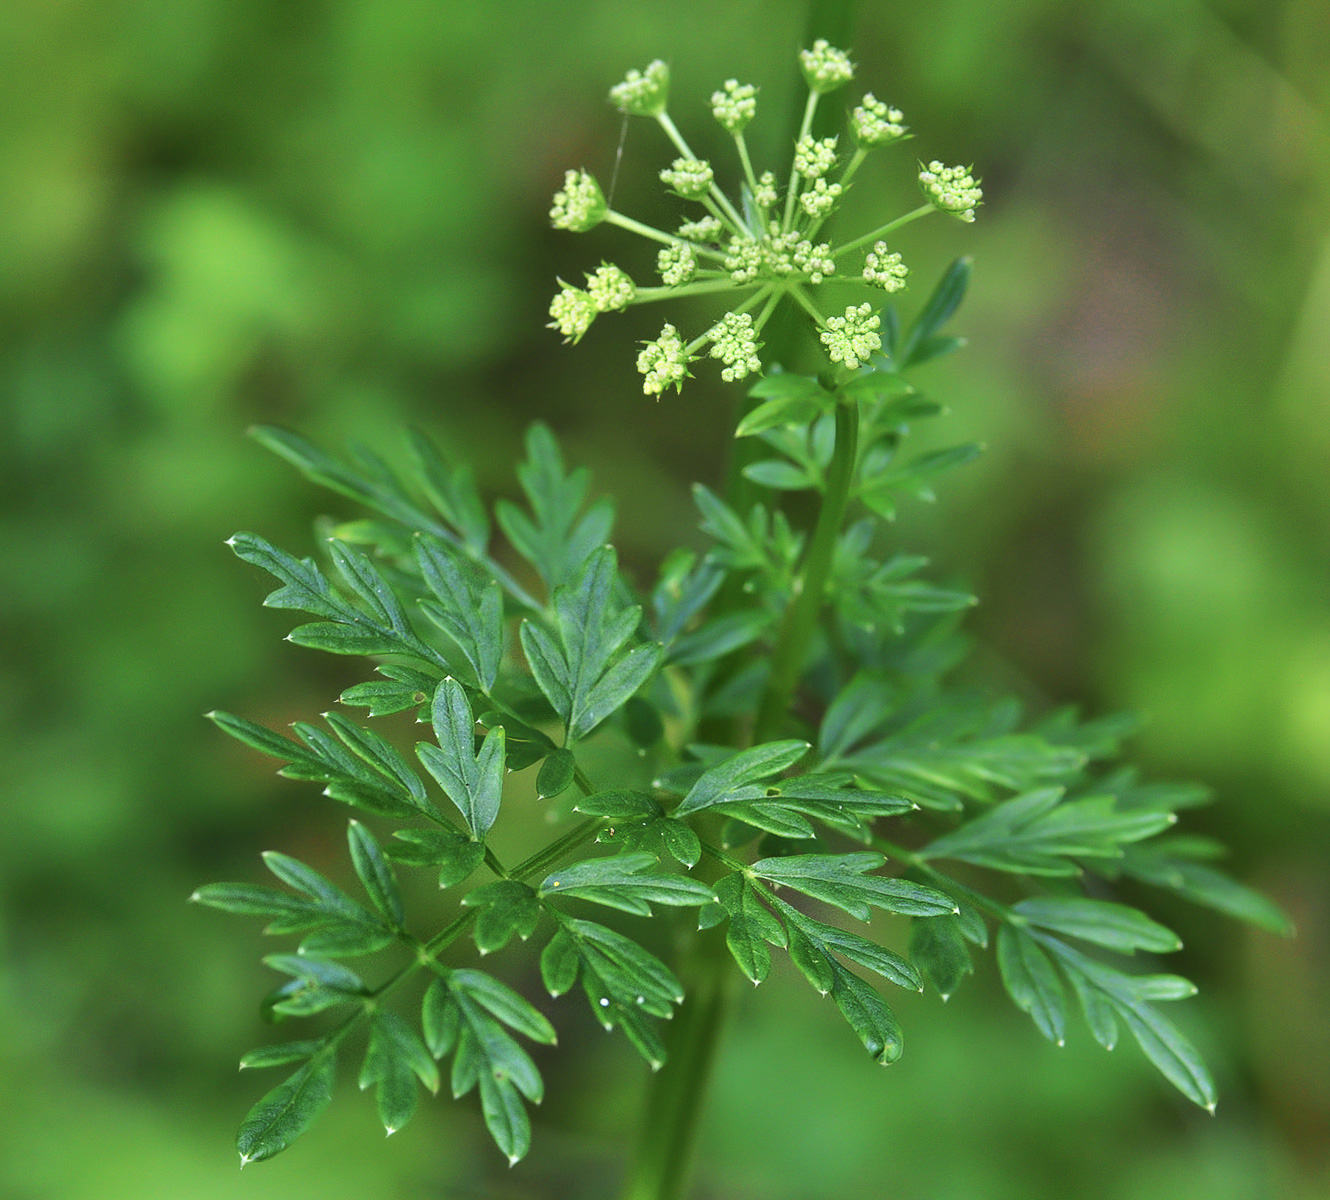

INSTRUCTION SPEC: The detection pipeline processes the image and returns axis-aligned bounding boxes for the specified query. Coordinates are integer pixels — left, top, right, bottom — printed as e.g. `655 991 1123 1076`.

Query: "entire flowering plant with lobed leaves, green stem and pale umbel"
194 41 1283 1200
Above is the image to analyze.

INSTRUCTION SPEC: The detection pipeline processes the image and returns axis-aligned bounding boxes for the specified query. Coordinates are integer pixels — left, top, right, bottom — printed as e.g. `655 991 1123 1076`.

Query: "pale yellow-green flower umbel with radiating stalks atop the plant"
549 41 983 396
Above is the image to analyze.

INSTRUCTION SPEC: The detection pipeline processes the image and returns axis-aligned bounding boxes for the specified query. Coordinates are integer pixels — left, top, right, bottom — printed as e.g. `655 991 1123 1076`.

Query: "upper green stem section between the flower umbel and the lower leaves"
753 403 859 742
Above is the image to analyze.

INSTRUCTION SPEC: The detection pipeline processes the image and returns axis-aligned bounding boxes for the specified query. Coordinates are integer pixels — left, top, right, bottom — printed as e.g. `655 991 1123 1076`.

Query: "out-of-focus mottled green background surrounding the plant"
0 0 1330 1200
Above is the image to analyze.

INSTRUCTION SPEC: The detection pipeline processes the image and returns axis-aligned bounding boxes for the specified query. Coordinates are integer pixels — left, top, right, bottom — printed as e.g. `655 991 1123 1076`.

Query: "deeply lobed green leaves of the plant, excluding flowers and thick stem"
194 251 1281 1160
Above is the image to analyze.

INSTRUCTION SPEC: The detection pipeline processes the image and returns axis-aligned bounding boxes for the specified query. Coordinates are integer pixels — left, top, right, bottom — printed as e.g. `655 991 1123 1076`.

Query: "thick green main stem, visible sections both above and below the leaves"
622 403 859 1200
